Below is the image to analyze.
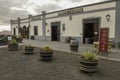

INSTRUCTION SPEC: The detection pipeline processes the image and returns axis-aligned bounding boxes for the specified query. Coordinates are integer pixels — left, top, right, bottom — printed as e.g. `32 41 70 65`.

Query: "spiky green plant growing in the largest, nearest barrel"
82 51 98 60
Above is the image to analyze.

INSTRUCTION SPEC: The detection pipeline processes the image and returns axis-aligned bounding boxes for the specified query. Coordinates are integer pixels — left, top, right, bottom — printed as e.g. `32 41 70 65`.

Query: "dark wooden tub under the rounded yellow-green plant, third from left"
40 49 53 60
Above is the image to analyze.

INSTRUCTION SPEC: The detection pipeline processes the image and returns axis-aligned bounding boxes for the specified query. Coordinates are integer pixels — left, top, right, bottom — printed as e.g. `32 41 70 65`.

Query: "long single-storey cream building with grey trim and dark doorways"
11 0 120 43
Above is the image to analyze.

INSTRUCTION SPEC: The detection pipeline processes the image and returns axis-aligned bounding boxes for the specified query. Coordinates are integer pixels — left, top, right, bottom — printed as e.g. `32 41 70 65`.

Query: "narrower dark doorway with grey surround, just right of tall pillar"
51 22 60 41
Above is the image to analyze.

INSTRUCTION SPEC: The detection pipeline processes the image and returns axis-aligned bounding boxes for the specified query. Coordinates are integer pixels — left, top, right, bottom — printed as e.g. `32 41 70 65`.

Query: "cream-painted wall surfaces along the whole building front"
12 2 116 41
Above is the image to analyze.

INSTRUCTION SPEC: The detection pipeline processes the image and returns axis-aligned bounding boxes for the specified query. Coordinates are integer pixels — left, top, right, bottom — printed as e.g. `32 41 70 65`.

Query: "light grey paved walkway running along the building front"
21 39 120 61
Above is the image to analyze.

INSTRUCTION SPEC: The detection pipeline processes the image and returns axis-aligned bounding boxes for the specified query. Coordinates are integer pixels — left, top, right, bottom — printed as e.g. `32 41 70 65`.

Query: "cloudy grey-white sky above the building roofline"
0 0 109 31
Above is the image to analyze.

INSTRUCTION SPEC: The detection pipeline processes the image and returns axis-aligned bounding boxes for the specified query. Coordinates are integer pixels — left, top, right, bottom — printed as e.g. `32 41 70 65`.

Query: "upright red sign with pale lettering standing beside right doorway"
99 28 109 53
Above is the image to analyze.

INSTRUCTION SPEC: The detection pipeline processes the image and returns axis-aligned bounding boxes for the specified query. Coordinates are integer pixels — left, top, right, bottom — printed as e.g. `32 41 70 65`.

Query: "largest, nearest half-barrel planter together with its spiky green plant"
79 51 99 72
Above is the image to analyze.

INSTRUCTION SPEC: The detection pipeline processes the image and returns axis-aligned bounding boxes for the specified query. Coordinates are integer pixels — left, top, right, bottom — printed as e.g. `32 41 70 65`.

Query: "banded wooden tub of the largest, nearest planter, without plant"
79 57 98 72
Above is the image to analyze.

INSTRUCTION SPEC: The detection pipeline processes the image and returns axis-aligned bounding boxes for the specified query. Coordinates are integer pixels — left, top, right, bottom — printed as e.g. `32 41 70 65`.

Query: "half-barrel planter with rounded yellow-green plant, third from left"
40 45 53 59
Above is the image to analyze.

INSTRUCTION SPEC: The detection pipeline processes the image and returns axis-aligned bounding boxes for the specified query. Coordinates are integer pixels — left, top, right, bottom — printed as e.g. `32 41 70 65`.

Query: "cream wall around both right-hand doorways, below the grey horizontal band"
46 10 115 37
